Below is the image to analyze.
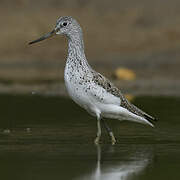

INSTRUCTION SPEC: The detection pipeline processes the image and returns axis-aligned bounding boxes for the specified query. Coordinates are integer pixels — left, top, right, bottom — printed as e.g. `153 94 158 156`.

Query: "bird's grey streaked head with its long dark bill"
29 16 82 44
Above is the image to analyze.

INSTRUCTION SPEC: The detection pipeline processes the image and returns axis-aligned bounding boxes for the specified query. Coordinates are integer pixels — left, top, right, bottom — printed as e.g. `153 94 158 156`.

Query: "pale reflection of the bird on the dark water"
78 145 153 180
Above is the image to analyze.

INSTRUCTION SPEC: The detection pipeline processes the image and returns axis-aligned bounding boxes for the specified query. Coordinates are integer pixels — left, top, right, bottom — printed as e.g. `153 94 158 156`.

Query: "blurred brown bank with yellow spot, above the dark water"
0 0 180 96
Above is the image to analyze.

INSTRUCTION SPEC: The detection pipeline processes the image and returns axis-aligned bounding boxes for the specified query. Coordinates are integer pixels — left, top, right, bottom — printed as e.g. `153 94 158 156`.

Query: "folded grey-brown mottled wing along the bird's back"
92 71 156 121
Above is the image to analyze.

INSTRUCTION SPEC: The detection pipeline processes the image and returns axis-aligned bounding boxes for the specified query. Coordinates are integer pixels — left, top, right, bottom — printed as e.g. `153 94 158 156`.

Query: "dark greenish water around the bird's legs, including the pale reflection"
0 95 180 180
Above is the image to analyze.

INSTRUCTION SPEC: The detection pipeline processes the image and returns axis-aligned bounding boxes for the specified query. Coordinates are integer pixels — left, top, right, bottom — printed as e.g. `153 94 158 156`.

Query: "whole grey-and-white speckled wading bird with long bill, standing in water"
29 16 155 144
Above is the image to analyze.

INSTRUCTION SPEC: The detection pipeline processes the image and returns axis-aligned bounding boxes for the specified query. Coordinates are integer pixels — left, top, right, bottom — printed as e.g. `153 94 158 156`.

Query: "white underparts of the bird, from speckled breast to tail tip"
65 68 150 124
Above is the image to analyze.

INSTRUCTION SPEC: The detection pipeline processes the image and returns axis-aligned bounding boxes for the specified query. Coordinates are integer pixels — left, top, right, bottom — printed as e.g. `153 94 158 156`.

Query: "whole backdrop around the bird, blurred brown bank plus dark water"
0 0 180 180
